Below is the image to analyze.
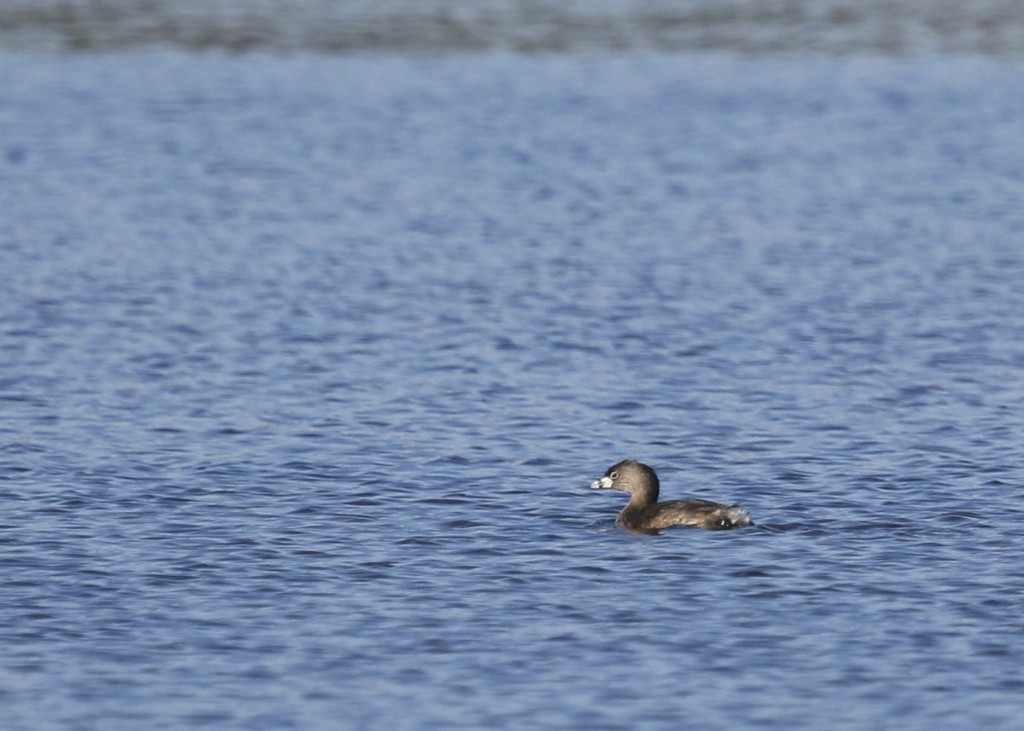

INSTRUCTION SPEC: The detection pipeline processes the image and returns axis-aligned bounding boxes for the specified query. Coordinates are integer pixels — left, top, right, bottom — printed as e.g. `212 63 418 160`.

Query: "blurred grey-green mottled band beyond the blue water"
6 0 1024 56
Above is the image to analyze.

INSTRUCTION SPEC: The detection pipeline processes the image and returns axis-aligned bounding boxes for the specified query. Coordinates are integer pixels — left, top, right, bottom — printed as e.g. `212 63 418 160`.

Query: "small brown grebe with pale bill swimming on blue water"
590 460 754 533
